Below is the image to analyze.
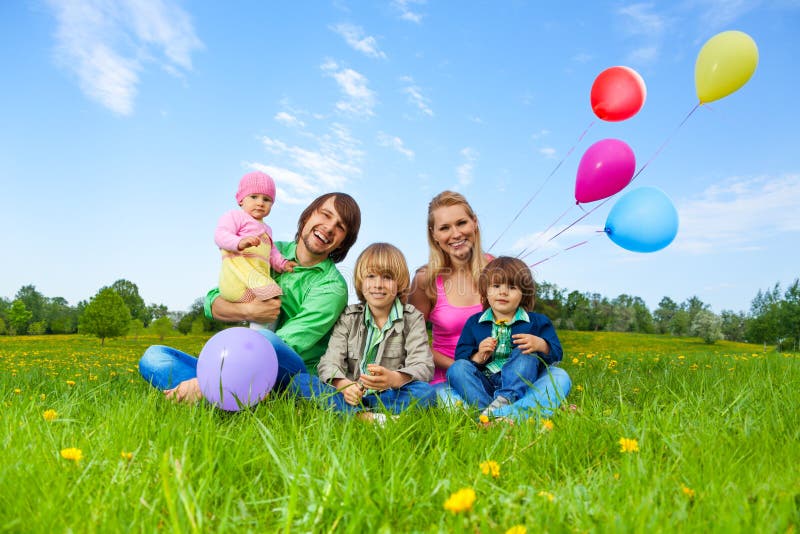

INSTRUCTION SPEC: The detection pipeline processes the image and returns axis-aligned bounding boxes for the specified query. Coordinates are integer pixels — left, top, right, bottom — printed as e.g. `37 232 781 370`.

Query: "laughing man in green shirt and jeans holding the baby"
139 193 361 401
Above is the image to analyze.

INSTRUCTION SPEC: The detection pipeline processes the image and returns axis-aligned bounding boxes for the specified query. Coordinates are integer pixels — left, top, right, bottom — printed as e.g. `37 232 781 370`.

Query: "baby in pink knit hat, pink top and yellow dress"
214 171 297 328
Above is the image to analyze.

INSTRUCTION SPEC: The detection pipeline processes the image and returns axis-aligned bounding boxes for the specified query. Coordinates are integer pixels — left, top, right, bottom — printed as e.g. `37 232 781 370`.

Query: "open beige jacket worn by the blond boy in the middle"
317 304 433 382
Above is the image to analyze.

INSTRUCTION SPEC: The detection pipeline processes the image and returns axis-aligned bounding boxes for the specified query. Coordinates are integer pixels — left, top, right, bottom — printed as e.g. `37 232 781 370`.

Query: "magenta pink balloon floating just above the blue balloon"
575 139 636 204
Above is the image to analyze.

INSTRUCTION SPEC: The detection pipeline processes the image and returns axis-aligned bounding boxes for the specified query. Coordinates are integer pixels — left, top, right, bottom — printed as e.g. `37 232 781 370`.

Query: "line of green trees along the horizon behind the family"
0 279 800 350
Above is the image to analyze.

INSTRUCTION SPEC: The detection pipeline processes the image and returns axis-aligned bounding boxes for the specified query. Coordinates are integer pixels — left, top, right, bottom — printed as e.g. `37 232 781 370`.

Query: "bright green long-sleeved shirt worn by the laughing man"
204 241 347 374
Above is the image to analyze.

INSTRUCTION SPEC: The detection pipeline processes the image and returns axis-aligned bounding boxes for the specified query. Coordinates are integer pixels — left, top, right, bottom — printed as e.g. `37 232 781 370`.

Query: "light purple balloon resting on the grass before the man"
197 327 278 412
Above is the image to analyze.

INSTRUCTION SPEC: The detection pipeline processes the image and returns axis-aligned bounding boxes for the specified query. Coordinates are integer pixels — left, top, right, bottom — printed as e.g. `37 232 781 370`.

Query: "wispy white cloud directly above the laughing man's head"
258 124 363 199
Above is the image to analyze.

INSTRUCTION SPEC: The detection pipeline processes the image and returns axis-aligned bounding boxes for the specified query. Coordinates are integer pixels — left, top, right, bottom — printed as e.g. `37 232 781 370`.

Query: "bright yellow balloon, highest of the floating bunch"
694 31 758 104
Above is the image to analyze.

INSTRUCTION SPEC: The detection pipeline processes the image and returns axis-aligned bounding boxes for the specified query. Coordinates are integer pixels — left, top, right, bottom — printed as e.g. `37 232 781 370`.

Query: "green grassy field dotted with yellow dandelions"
0 331 800 533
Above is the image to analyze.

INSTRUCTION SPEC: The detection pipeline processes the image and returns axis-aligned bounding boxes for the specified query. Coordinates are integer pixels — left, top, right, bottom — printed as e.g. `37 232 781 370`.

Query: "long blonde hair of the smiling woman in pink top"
425 191 486 302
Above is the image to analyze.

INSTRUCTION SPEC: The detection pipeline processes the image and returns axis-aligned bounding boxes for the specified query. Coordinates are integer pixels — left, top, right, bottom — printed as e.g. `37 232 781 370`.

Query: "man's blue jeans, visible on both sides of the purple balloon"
139 329 308 391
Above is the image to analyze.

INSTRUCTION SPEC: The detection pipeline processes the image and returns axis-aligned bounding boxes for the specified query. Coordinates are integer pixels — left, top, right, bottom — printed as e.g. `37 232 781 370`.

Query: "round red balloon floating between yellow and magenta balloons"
591 67 647 122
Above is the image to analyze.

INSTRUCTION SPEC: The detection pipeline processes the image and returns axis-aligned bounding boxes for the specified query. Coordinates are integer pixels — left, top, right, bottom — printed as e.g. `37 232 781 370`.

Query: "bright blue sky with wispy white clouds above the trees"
0 0 800 312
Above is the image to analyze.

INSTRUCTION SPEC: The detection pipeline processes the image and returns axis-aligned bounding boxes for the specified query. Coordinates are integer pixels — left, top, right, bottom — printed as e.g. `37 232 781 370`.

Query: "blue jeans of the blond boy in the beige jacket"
288 373 436 414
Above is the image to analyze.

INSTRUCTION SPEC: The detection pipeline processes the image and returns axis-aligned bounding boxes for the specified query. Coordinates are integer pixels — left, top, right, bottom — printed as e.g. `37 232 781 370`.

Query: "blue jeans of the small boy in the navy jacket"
447 349 540 409
